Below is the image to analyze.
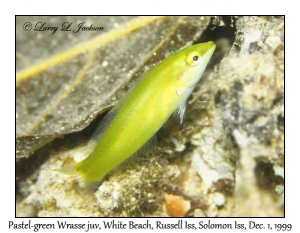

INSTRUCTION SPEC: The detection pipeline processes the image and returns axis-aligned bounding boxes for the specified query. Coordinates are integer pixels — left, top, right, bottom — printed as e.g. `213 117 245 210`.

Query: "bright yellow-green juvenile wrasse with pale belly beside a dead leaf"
63 41 216 183
